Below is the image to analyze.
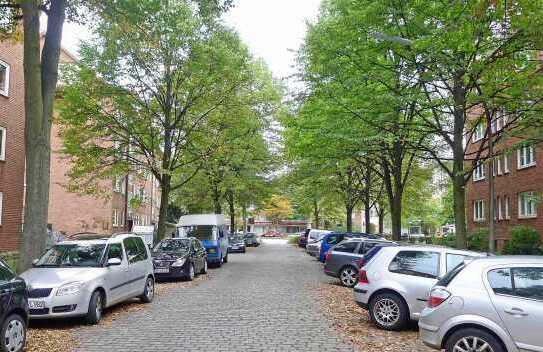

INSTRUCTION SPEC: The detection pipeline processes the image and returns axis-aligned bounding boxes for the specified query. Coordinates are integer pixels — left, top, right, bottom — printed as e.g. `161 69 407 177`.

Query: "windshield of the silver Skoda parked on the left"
36 243 106 267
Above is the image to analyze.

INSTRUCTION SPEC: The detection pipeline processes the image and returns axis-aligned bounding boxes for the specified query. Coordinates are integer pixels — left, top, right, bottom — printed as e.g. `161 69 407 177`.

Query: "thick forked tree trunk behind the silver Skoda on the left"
19 0 66 270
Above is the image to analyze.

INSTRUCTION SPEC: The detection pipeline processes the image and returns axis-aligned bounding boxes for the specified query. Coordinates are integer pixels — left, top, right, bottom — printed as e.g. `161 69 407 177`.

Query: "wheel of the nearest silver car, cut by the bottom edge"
445 328 505 352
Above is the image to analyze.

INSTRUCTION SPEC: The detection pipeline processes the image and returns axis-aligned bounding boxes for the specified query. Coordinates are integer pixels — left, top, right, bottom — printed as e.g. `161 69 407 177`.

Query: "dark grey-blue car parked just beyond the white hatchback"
323 237 395 287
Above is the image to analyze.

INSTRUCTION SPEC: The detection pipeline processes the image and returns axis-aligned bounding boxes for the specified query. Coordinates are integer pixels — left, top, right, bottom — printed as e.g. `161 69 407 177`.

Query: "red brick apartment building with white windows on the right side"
466 115 543 250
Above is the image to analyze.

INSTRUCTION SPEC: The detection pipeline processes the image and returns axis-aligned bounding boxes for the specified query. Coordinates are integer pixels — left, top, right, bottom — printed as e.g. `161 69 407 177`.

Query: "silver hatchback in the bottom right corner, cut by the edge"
419 256 543 352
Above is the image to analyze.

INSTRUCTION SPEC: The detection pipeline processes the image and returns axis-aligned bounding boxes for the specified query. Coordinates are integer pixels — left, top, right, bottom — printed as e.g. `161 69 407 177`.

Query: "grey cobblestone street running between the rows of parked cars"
77 240 353 352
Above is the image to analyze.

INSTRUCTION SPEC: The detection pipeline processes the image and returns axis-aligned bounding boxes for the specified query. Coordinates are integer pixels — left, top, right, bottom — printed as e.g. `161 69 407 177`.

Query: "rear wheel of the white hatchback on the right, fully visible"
369 293 409 330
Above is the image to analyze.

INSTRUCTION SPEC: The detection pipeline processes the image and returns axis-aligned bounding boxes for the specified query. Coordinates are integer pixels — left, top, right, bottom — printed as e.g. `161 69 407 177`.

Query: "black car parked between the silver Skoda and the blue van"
152 237 207 281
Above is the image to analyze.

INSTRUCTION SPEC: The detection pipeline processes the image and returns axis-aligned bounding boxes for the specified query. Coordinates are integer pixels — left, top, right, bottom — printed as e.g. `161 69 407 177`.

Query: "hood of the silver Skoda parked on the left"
20 267 104 288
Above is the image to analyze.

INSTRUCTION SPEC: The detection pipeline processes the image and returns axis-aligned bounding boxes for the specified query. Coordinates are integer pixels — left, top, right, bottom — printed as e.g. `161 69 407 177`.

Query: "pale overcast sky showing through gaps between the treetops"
63 0 320 78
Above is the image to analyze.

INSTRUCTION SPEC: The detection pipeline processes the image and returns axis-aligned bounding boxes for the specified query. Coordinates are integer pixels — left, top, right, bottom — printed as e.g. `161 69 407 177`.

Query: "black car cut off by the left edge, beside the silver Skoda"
0 259 28 352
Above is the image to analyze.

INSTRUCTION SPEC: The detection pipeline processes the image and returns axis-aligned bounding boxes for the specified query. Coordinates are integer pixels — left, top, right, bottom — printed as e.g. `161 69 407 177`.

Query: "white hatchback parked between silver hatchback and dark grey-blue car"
354 245 486 330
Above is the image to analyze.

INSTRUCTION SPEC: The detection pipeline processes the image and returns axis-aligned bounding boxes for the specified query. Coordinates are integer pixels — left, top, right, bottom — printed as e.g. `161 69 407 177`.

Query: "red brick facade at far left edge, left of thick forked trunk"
0 41 25 251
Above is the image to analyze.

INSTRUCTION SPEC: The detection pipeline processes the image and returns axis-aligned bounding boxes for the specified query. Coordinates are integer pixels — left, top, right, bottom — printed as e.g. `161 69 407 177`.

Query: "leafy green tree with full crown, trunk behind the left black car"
59 0 252 238
